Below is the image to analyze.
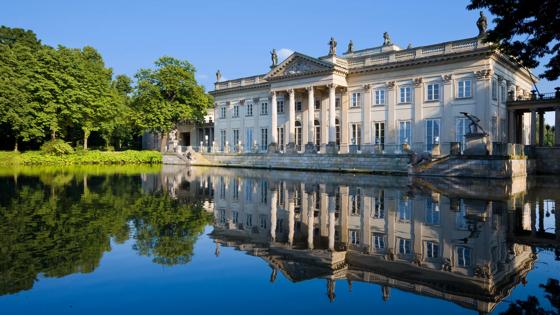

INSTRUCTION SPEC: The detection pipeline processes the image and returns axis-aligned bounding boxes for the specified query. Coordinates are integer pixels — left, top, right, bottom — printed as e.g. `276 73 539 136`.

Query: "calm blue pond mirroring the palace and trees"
0 166 560 314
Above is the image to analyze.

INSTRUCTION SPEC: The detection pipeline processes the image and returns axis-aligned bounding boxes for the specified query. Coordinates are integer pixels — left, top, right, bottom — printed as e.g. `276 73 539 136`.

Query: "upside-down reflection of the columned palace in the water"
156 168 558 313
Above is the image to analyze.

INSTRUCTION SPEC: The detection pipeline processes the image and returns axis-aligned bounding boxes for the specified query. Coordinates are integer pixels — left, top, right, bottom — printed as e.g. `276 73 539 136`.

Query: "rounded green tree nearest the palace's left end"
132 57 213 151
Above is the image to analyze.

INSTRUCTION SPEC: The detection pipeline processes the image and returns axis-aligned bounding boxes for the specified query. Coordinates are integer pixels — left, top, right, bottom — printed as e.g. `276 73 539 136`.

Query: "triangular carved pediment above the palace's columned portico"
264 52 334 80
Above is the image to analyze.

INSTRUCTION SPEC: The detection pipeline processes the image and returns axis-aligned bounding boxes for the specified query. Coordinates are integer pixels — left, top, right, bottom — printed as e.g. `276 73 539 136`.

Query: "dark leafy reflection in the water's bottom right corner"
501 279 560 315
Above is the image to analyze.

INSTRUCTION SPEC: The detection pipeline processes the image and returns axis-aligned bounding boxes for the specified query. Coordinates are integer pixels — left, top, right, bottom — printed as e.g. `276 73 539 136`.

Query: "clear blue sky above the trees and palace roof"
0 0 560 121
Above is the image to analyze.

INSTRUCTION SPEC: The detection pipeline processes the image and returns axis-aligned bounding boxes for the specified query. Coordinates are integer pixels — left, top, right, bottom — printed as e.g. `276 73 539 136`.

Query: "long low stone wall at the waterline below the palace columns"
191 153 409 175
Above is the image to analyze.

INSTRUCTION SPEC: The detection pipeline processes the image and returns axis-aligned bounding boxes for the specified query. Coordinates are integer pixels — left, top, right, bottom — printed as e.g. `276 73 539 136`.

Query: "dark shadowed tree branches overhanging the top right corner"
467 0 560 81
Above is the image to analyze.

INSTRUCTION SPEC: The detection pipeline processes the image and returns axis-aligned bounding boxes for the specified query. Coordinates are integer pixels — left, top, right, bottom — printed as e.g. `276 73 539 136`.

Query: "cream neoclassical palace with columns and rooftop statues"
210 27 535 153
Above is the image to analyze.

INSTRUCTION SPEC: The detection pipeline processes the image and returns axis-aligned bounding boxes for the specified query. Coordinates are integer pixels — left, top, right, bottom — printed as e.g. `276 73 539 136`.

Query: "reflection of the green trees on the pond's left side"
0 169 211 295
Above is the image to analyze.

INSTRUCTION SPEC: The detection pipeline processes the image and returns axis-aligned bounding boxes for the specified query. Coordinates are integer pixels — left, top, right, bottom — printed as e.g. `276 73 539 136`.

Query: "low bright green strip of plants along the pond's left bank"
0 150 162 166
